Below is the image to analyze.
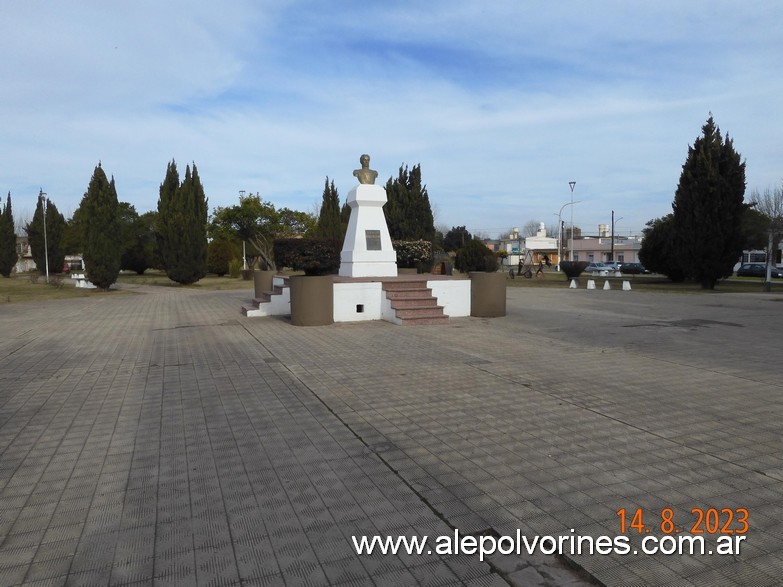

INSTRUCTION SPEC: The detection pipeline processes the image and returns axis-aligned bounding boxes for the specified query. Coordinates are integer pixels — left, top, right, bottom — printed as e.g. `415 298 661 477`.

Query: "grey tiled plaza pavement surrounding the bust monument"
0 282 783 587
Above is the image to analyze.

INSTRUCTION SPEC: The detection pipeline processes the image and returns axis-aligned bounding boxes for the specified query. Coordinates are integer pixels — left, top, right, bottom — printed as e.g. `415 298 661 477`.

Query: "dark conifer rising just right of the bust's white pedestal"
383 165 435 242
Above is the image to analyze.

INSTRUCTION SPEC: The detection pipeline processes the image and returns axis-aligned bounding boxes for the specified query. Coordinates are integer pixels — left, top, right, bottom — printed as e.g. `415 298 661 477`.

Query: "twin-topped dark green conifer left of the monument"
157 161 207 285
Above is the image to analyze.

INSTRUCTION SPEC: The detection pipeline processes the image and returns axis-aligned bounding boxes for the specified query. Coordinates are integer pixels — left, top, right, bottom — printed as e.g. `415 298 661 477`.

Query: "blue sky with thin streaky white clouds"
0 0 783 237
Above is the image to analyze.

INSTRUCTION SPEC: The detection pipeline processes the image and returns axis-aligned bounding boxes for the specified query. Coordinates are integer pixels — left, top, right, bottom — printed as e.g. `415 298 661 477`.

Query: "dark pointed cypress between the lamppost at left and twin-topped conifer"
80 163 124 291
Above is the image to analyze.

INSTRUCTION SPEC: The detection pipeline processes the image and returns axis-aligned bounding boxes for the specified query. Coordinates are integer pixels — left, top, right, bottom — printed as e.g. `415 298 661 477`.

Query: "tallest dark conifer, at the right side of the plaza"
672 115 745 289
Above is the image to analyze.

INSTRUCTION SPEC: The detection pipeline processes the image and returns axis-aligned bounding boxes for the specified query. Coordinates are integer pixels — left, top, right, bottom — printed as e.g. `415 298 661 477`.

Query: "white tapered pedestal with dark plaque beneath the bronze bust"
339 184 397 277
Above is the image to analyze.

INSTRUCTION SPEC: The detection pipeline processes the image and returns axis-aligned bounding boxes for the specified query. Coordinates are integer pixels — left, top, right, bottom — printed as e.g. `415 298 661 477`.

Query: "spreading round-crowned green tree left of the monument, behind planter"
209 194 316 269
